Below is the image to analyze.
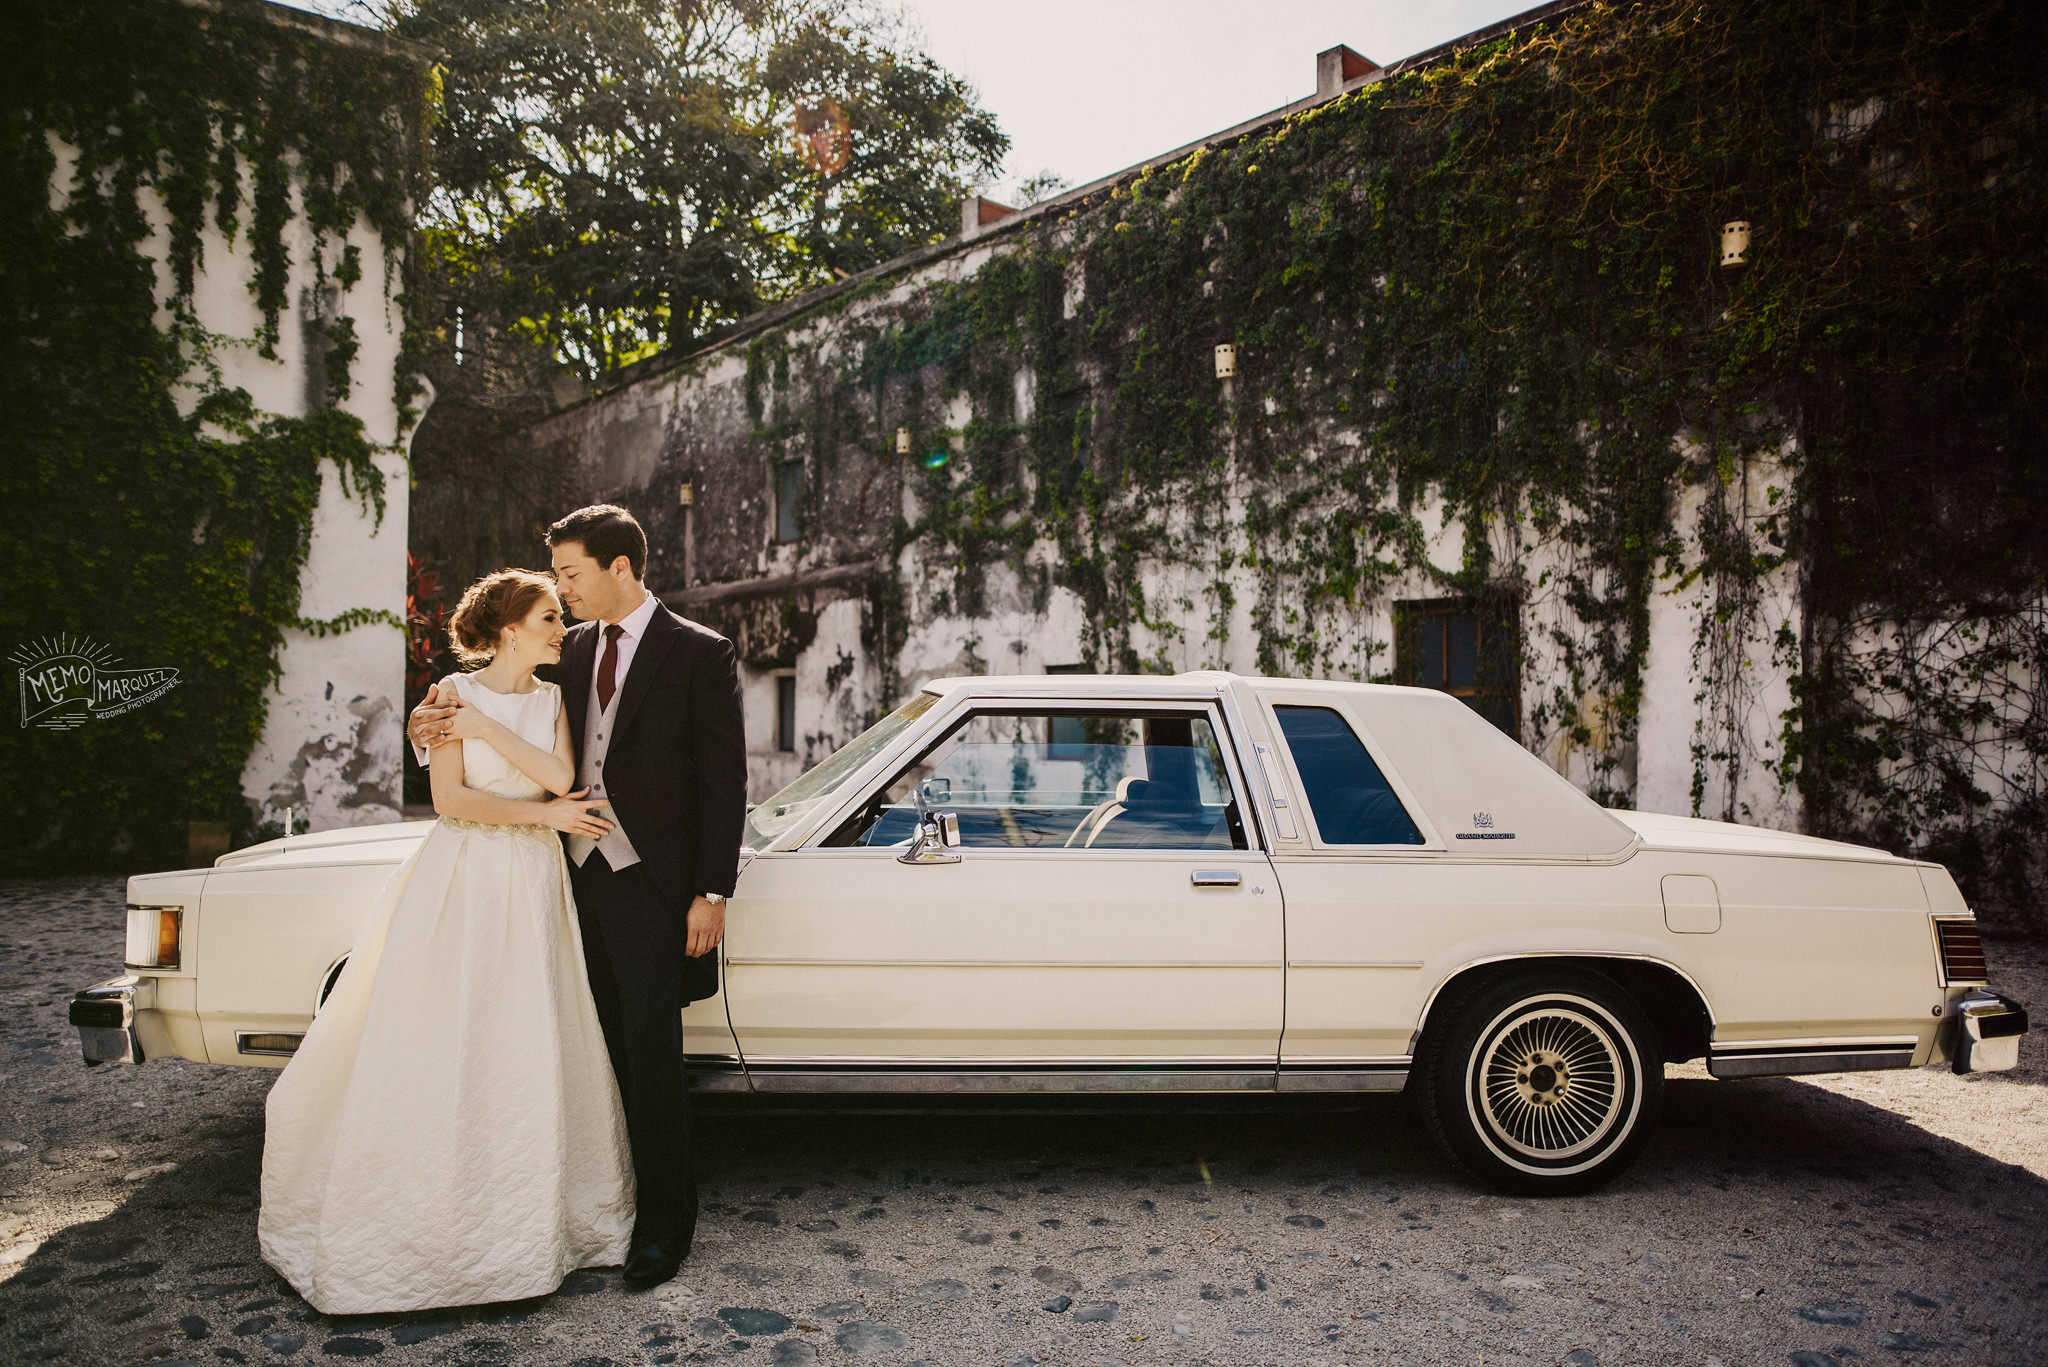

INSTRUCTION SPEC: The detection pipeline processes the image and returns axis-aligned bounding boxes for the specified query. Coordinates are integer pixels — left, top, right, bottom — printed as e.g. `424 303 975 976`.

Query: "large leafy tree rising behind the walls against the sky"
389 0 1008 377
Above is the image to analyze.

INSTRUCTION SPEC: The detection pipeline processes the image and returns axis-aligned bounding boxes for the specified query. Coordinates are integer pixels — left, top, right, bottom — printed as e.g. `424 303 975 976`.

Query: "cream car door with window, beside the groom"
725 699 1284 1090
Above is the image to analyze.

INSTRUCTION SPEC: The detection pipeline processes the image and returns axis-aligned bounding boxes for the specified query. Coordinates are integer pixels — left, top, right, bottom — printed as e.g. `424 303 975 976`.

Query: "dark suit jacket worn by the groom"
559 605 748 1002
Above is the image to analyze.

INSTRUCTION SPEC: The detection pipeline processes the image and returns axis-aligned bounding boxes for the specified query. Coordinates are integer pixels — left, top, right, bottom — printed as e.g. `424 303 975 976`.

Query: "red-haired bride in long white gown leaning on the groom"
258 570 633 1314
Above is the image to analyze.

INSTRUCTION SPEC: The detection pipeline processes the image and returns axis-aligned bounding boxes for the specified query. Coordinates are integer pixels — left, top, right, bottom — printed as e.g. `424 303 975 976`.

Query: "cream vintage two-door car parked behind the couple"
72 672 2025 1193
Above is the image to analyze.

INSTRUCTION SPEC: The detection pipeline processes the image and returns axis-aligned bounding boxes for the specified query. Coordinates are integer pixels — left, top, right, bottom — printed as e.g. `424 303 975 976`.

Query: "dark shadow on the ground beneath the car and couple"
0 1080 2048 1367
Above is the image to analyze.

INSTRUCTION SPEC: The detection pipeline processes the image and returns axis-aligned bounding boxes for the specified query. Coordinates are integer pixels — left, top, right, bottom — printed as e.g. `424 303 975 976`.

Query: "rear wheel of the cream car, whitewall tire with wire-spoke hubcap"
1413 971 1663 1197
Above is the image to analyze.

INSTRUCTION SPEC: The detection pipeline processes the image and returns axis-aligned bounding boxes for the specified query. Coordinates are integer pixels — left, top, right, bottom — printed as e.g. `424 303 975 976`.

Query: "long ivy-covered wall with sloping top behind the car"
503 0 2048 928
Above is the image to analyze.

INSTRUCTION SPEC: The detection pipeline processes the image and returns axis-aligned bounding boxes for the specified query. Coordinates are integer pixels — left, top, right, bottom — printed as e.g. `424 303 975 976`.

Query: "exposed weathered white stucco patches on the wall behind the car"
520 232 1798 828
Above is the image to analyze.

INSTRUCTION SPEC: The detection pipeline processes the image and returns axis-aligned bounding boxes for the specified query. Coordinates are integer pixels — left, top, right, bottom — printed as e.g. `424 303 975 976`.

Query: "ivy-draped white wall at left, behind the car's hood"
0 0 436 871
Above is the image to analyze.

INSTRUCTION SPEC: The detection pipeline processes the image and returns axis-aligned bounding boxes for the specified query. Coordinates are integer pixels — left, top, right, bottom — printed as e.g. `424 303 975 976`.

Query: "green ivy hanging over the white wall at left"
0 0 434 871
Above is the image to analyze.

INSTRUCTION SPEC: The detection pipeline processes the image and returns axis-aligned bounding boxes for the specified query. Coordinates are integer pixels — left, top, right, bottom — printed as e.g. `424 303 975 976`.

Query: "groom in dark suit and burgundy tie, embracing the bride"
408 504 748 1287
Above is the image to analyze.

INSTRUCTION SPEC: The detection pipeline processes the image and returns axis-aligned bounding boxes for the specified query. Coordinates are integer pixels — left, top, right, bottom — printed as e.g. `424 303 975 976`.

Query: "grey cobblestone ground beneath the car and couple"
0 879 2048 1367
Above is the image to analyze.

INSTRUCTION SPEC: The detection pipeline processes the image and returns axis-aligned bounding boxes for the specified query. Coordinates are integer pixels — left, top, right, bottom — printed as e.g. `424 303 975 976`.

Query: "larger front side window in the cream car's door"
823 709 1247 851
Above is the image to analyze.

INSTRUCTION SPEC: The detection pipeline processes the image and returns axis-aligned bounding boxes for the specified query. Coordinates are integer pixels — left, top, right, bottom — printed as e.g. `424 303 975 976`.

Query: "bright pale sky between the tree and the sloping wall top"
283 0 1540 203
